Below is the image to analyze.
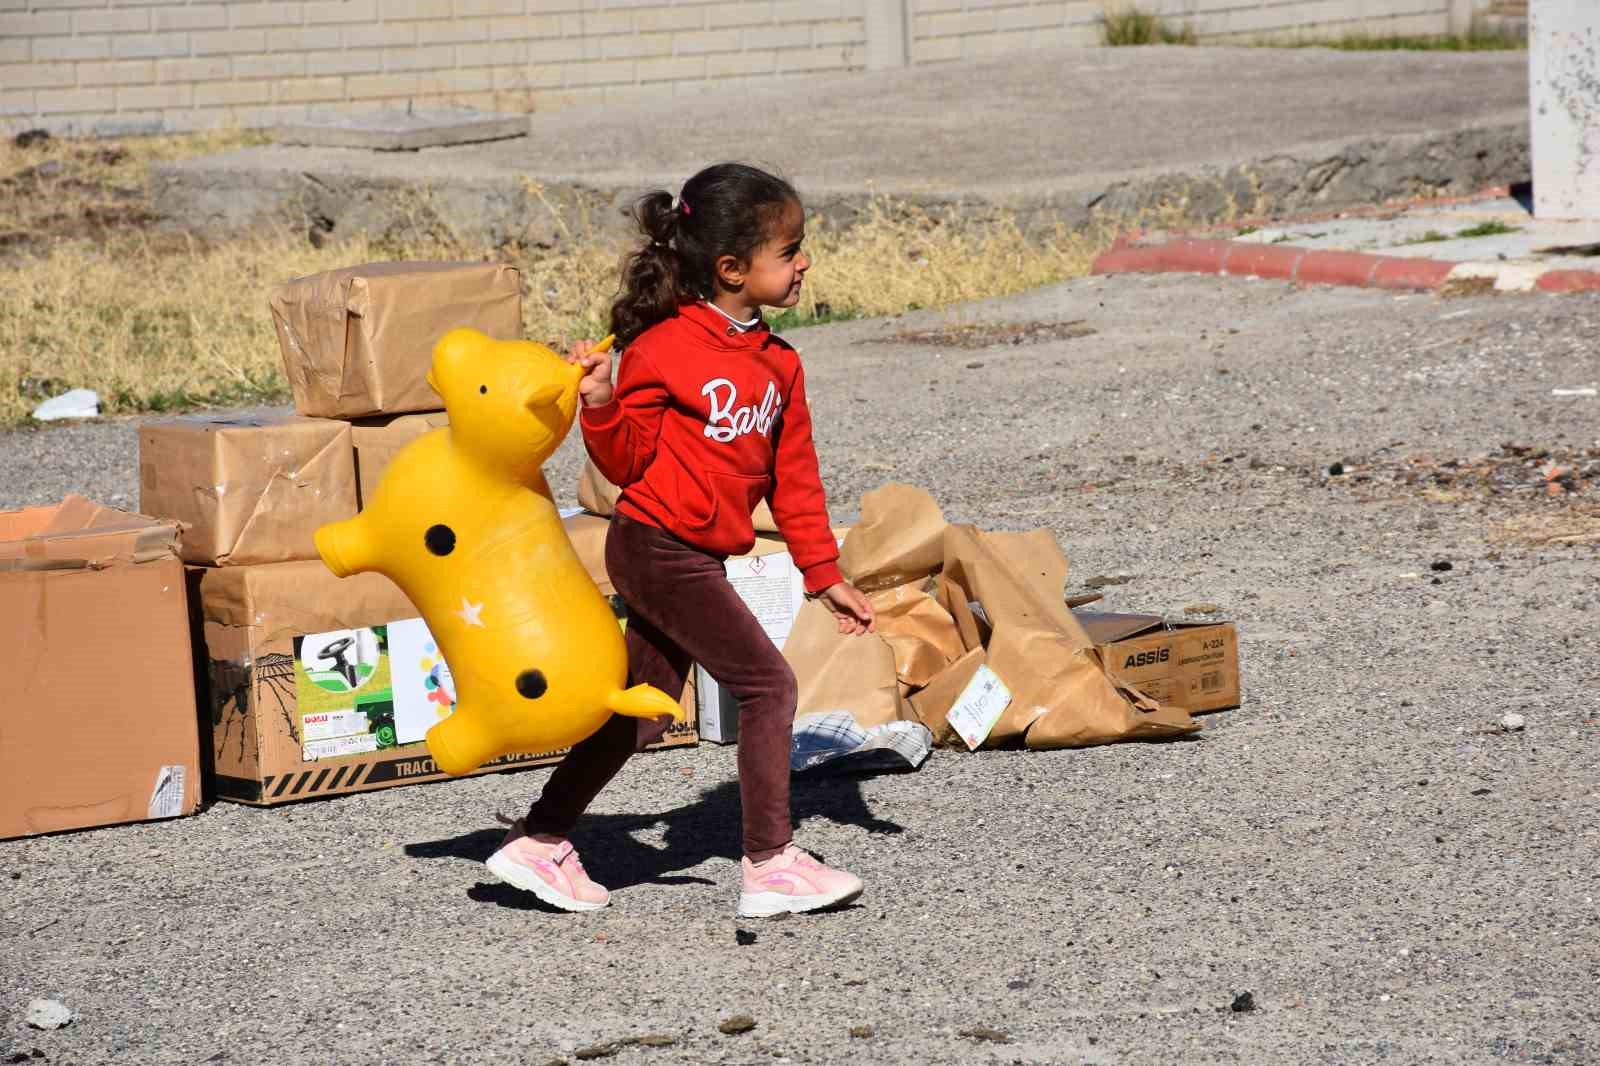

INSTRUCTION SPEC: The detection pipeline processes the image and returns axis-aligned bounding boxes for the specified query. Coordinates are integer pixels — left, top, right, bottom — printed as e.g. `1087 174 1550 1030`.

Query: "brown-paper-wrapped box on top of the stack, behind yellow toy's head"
267 262 522 418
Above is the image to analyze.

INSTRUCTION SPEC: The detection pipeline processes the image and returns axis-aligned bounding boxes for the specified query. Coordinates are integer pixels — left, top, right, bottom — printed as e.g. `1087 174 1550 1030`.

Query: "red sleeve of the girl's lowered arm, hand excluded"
766 360 845 594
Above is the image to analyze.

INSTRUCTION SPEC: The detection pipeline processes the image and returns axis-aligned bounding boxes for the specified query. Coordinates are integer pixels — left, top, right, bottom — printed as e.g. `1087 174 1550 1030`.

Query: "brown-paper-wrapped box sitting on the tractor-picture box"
139 415 355 567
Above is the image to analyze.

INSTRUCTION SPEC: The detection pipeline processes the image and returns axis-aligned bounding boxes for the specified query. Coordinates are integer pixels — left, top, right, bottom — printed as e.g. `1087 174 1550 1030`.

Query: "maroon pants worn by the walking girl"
526 515 795 863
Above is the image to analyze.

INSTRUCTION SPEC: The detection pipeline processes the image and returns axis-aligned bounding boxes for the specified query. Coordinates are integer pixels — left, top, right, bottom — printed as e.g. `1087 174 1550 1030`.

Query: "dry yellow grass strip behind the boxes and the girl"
0 134 1109 423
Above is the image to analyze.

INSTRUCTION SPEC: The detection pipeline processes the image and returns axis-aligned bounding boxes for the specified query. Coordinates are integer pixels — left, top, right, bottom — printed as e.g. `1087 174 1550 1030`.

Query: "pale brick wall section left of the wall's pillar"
0 0 882 131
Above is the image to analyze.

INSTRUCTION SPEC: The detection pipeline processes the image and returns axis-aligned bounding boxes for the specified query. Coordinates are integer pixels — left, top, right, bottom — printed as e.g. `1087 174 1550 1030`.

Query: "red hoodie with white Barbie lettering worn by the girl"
579 303 845 592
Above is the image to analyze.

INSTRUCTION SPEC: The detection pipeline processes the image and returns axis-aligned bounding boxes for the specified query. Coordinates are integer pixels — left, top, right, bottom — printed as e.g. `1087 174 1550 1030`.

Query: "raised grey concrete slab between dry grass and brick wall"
155 46 1530 242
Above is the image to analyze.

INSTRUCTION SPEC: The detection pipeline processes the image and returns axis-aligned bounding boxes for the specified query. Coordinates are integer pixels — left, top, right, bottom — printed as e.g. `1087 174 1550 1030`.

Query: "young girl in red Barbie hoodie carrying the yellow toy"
488 163 874 917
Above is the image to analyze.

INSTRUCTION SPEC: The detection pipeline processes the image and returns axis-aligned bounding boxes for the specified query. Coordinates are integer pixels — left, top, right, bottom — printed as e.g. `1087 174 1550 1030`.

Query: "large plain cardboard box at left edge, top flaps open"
0 496 200 837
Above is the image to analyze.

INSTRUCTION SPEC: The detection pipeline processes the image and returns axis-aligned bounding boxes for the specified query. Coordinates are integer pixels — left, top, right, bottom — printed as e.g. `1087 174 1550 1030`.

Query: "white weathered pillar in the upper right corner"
1528 0 1600 221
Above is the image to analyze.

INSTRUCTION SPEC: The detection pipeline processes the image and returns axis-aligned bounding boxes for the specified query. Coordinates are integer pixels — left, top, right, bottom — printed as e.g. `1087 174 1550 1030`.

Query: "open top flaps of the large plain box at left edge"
0 495 178 570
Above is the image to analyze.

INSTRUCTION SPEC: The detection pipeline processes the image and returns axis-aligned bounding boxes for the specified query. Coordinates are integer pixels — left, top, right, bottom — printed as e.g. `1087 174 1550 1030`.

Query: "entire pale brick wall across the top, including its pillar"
0 0 1497 133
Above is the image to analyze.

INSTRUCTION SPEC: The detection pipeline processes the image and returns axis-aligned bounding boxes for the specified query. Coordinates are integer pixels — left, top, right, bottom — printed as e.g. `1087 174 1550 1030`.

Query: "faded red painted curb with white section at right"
1091 238 1600 293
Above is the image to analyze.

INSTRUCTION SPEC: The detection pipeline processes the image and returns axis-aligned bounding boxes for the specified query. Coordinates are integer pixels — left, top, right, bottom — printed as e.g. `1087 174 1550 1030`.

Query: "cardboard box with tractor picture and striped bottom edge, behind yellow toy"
190 512 698 805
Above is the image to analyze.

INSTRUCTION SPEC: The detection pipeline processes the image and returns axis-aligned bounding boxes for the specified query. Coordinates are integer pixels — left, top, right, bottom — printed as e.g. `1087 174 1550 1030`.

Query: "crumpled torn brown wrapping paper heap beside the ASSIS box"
832 485 1200 747
